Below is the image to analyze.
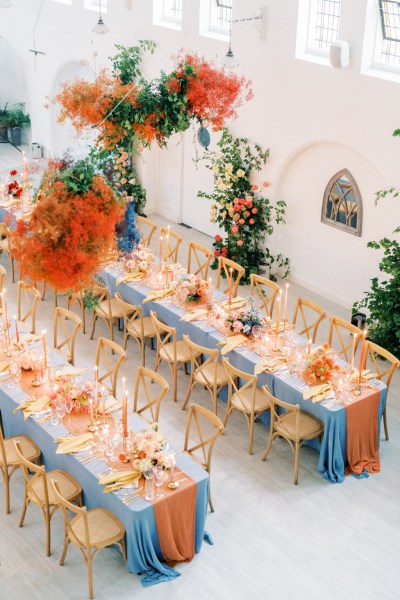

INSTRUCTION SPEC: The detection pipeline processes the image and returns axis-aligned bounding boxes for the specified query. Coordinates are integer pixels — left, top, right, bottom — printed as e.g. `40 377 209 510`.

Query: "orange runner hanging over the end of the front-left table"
153 469 196 566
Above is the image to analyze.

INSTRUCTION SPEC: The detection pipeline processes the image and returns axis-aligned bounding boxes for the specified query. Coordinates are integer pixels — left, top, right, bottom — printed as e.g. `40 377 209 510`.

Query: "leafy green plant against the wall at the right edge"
353 232 400 357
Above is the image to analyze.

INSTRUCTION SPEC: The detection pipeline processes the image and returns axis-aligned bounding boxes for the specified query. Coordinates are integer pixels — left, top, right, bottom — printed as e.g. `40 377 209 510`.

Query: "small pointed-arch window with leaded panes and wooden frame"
321 169 362 236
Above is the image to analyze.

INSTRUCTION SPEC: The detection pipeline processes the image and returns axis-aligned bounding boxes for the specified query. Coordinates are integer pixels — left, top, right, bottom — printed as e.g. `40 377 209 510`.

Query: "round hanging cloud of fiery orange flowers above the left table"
13 161 124 292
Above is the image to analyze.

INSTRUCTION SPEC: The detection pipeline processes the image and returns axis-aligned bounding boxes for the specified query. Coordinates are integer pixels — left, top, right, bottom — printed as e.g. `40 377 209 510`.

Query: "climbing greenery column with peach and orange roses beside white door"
198 128 290 282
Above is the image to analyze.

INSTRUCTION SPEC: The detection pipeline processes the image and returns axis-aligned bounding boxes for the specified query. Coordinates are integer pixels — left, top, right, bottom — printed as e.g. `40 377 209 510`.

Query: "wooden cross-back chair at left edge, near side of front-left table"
0 427 41 515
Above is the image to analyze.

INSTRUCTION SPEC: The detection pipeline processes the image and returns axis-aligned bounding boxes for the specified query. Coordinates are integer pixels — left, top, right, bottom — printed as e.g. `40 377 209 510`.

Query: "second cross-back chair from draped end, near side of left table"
14 440 82 556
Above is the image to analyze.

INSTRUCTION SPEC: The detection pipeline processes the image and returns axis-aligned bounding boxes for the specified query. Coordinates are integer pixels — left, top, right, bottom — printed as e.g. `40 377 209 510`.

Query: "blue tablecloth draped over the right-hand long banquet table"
99 265 386 483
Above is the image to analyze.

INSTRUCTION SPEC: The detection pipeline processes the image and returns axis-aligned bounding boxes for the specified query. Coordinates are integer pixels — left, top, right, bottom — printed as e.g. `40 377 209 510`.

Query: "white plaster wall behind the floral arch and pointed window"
0 0 400 306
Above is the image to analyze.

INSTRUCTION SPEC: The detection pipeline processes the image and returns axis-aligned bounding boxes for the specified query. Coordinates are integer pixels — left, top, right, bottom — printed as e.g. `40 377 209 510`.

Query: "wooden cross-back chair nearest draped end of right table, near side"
262 386 324 485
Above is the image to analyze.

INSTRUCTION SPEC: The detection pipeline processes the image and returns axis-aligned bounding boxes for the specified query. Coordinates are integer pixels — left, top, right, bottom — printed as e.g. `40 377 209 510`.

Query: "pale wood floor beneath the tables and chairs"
0 145 400 600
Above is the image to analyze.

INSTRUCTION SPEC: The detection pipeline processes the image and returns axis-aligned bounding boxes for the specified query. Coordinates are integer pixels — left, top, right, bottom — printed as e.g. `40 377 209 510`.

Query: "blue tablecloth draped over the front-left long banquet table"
0 360 208 585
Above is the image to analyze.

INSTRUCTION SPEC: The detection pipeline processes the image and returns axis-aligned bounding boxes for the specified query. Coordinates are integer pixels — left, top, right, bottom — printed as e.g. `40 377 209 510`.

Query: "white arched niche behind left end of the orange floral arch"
50 61 96 158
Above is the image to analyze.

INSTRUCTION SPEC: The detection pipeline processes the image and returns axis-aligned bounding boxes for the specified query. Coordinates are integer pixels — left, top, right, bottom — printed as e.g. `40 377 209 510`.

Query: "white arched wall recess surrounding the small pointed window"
271 140 386 308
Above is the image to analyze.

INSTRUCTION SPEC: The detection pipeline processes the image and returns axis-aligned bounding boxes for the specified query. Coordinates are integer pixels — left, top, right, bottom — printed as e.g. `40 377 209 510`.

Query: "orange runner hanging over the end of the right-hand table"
346 390 380 475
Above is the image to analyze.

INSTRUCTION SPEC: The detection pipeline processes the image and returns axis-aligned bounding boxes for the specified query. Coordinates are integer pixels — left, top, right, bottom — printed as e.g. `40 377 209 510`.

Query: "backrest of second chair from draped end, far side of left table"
133 367 169 423
